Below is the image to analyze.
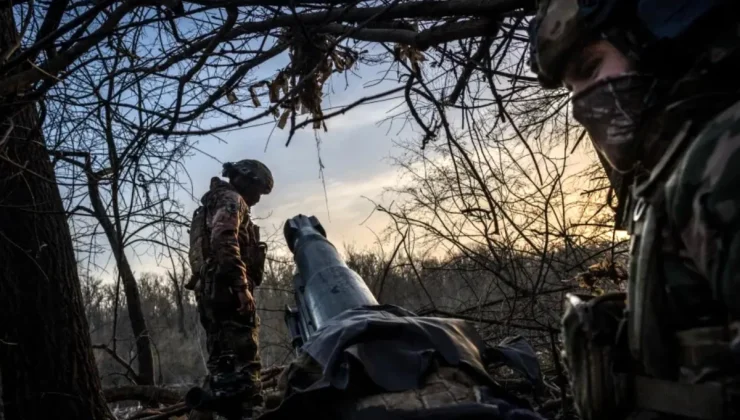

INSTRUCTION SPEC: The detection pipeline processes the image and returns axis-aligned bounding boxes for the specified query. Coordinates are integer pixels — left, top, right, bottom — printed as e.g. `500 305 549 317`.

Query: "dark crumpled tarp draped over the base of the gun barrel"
262 305 539 419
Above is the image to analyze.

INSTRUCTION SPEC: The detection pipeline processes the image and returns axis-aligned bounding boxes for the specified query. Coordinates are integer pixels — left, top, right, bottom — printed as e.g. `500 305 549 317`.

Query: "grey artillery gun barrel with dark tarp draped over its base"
270 215 542 420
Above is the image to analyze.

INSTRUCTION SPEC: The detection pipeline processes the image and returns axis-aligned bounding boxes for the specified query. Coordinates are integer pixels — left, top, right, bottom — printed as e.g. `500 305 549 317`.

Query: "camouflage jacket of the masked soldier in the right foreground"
627 23 740 418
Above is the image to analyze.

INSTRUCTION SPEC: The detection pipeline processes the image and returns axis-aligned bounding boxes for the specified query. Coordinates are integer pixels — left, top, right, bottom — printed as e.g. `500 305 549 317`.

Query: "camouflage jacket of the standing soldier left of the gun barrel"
201 177 256 290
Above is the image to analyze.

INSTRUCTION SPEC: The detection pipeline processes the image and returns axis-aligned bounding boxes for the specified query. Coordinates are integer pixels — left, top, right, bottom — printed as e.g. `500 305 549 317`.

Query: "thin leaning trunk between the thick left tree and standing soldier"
86 176 154 385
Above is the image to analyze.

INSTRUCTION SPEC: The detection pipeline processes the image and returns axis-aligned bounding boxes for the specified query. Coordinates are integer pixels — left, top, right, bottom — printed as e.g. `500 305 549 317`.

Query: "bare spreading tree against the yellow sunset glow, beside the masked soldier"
364 32 626 407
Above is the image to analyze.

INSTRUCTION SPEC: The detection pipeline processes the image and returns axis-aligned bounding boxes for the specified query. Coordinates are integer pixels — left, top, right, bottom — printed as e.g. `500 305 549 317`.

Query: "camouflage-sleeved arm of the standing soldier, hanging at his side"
210 191 248 286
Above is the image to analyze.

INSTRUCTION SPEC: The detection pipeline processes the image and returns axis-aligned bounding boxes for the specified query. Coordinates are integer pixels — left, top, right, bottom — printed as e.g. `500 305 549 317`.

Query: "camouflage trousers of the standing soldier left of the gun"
198 299 262 405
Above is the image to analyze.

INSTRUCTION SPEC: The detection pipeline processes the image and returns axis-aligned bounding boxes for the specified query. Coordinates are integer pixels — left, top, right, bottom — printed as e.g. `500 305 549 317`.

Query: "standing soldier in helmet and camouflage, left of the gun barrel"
188 160 273 412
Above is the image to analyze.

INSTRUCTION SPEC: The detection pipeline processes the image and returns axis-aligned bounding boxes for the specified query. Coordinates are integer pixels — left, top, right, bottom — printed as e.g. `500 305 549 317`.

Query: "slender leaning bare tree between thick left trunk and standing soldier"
49 83 187 385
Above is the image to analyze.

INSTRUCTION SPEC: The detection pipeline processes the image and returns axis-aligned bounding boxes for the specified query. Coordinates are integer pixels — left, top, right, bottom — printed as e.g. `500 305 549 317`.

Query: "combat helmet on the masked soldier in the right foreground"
529 0 734 229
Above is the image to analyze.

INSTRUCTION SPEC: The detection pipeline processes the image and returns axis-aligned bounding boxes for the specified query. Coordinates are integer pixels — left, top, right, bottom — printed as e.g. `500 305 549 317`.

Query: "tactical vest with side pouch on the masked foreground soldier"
563 13 740 420
